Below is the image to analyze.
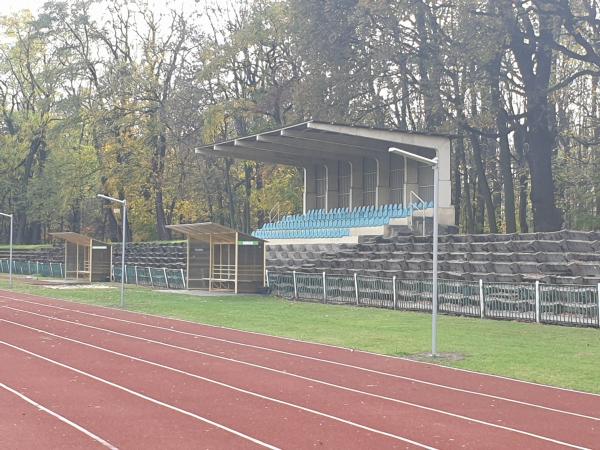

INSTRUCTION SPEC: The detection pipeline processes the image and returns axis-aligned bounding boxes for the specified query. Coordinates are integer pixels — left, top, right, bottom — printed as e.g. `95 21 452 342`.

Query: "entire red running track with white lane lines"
0 291 600 449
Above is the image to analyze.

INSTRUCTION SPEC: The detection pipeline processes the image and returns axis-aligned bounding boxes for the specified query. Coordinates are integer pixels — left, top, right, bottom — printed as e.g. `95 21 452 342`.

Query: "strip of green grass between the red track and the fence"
0 280 600 393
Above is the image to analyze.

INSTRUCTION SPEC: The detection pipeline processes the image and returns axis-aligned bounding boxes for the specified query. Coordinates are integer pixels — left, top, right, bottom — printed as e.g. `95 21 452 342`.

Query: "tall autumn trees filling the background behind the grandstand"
0 0 600 243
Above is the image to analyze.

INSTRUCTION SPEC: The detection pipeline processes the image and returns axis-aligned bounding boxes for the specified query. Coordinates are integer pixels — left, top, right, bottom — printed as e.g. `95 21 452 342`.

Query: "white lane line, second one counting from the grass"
0 296 600 421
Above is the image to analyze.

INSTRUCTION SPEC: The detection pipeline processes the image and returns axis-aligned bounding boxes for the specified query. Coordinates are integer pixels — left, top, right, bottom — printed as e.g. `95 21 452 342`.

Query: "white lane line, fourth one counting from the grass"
0 319 438 449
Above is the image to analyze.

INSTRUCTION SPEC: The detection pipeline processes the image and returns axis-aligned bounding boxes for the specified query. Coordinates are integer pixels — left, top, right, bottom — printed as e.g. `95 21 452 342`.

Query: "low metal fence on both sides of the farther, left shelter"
0 259 186 289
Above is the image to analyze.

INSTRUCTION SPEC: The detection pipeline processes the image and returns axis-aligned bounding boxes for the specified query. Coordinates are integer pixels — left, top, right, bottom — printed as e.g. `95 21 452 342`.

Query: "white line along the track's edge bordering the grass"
0 290 600 400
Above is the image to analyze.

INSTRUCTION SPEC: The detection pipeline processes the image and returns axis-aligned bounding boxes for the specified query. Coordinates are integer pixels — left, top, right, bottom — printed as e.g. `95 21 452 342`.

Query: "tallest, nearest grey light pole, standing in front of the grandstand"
389 147 440 358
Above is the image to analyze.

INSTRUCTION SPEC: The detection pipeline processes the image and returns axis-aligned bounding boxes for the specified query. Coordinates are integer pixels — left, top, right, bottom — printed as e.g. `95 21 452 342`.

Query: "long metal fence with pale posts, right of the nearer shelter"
267 271 600 327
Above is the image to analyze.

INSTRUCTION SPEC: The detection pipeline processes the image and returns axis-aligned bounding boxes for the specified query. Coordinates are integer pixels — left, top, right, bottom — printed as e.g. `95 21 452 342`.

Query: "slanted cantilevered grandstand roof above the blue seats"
196 120 453 167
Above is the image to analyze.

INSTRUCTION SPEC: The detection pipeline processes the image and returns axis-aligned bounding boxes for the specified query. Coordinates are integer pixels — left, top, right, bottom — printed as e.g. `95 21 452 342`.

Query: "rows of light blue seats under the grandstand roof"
253 203 433 239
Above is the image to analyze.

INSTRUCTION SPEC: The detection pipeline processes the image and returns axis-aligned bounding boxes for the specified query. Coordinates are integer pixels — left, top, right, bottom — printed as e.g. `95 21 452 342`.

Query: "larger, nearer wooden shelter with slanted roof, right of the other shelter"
168 222 265 294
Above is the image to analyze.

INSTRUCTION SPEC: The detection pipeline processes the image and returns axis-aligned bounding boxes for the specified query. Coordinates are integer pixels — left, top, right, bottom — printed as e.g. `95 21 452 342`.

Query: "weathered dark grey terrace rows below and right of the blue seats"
267 230 600 285
